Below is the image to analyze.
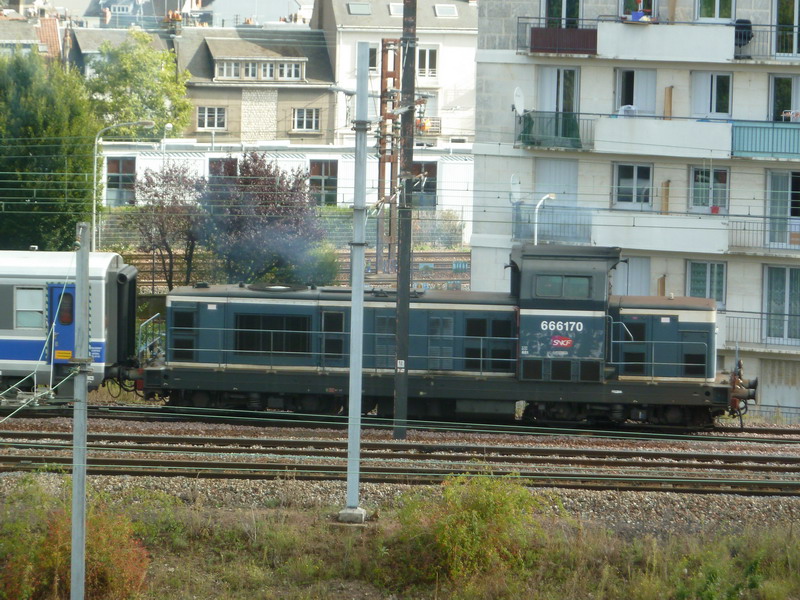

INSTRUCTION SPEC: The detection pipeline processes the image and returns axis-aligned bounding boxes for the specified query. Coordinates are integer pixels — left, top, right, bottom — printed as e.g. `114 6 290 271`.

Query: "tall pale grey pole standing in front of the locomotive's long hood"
339 42 369 523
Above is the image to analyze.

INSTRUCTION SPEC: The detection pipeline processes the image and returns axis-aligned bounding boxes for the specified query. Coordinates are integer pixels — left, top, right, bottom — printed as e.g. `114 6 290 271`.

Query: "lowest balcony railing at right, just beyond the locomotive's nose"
724 311 800 350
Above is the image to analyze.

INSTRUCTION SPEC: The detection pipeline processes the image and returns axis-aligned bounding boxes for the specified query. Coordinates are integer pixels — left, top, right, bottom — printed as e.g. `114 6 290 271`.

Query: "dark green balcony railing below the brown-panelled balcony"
514 110 597 149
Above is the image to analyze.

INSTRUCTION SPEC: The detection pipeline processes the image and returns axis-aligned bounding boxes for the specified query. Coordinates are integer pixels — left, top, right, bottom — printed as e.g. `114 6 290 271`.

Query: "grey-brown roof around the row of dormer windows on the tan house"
174 25 333 86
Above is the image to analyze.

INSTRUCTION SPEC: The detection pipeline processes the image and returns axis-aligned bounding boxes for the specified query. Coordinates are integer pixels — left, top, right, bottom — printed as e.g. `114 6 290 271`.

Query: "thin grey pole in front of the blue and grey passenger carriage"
70 223 94 600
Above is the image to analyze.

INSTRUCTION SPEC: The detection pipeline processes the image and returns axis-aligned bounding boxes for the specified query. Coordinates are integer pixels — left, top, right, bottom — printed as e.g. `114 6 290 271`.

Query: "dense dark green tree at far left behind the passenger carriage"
0 51 101 250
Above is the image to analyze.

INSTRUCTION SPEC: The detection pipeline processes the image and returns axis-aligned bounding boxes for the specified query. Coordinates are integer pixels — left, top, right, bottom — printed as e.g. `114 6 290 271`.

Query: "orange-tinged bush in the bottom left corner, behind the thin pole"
0 480 149 600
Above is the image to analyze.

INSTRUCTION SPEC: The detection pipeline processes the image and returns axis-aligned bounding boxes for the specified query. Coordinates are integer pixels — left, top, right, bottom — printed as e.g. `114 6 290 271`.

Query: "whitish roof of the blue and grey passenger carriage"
0 250 122 280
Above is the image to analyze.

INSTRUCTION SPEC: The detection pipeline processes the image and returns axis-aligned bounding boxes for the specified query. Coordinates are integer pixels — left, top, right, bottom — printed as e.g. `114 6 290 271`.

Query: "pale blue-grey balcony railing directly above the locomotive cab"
512 202 592 244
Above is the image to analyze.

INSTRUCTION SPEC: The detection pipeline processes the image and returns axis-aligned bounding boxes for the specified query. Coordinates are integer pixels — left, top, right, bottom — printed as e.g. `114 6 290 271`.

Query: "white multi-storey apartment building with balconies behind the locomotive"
471 0 800 413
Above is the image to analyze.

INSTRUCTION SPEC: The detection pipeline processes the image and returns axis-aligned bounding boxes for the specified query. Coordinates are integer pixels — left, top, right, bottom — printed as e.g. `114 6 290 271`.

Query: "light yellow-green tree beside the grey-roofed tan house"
87 30 192 135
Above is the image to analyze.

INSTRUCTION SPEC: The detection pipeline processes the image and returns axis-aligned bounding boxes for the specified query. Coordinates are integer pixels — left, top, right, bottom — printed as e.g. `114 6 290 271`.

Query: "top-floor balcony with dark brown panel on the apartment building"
517 17 597 54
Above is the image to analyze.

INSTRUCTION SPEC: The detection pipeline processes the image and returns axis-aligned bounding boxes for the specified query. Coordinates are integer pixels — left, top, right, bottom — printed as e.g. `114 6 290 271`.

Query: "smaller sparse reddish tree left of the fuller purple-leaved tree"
131 162 205 290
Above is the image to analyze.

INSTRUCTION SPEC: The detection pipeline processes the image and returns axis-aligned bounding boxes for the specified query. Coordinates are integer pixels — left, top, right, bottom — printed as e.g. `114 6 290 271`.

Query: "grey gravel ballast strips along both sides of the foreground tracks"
0 419 800 537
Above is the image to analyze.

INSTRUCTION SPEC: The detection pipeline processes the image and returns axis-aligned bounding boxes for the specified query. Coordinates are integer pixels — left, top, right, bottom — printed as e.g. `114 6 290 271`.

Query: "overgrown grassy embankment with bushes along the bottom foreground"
0 476 800 600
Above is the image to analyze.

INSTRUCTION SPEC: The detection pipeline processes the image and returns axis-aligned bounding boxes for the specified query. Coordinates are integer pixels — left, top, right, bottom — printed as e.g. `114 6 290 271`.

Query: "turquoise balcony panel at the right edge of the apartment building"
731 121 800 159
